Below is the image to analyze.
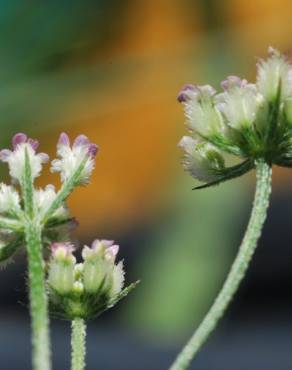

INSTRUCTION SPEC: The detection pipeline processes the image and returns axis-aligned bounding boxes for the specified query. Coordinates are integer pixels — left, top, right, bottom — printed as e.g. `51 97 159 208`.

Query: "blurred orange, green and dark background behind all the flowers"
0 0 292 370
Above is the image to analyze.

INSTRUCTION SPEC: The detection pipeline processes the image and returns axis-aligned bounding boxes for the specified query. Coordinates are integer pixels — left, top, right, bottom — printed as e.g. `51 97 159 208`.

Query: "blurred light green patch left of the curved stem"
125 175 250 343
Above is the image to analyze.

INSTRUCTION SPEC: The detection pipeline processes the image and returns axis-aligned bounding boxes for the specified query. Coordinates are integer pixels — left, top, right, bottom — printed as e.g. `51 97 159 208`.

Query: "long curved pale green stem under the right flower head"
170 160 272 370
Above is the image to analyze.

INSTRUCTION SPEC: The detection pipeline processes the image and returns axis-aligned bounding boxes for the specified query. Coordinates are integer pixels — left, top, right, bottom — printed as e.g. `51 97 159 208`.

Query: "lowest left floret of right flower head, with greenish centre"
179 136 224 182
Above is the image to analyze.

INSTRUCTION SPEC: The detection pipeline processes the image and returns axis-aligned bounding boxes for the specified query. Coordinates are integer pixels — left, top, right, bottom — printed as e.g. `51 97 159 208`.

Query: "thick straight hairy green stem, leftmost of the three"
25 222 51 370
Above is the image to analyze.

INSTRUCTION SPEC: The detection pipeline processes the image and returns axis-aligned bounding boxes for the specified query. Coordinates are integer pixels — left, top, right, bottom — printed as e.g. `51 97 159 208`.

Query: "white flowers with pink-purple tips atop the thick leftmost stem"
0 133 97 261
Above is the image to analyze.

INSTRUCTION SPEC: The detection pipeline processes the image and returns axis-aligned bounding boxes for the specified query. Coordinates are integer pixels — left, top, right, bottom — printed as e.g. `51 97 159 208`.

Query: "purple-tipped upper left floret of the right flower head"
178 85 224 136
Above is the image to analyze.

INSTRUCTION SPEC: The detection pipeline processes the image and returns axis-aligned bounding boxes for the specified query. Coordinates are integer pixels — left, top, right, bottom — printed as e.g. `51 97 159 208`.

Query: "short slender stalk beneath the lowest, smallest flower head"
71 318 86 370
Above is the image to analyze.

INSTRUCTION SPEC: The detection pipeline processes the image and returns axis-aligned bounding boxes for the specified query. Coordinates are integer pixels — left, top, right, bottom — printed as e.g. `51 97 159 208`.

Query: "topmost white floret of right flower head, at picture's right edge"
257 47 292 101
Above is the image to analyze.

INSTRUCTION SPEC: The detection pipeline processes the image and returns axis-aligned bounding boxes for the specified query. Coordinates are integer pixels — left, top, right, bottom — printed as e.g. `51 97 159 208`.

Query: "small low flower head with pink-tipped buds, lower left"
48 240 134 320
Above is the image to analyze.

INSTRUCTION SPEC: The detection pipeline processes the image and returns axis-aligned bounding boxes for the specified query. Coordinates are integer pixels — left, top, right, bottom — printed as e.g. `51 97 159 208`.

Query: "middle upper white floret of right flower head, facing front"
216 76 262 129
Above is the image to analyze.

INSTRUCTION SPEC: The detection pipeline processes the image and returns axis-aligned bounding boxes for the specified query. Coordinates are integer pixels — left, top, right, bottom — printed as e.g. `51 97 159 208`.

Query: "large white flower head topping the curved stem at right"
178 48 292 187
